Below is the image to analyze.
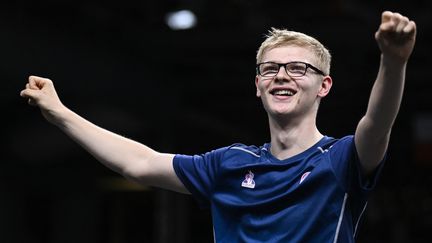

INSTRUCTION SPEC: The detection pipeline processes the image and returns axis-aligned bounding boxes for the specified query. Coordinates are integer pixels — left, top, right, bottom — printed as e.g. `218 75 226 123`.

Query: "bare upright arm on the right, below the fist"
355 56 406 175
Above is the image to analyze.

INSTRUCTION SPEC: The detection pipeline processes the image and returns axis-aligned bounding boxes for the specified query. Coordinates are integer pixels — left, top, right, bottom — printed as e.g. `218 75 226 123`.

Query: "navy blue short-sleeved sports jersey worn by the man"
173 136 383 243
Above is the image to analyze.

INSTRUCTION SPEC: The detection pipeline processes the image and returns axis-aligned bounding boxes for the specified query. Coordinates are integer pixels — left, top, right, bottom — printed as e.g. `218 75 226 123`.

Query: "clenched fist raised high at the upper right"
375 11 416 62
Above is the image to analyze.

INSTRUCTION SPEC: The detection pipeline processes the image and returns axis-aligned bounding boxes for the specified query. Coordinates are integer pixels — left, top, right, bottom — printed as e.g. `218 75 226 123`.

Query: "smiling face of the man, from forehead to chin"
255 46 332 120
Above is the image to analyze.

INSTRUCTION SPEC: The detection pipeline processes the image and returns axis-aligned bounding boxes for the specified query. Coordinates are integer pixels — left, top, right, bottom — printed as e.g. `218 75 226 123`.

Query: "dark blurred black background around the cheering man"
0 0 432 243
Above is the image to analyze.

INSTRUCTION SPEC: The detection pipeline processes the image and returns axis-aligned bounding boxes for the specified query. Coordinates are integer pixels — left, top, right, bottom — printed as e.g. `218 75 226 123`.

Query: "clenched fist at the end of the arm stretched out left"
20 76 64 123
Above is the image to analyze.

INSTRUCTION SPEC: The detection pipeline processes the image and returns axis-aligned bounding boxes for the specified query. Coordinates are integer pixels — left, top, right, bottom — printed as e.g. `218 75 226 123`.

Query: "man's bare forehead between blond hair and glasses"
262 45 316 63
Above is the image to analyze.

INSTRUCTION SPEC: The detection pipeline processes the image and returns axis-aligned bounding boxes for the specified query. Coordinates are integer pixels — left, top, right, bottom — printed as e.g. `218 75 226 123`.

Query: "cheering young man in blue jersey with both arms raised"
21 11 416 243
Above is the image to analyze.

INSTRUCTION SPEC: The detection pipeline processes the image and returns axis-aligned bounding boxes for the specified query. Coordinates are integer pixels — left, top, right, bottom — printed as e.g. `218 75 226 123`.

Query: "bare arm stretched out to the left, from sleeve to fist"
21 76 188 193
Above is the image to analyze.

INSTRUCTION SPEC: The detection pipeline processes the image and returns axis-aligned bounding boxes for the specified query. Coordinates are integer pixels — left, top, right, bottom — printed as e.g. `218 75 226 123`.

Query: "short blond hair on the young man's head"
256 28 331 75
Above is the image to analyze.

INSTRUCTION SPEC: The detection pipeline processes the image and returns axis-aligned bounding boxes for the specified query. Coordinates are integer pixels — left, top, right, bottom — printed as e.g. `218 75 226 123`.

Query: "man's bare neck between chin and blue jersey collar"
269 113 323 160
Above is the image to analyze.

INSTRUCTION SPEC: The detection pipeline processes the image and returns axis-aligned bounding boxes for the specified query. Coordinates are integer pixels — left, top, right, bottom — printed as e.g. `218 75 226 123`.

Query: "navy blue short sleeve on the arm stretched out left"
173 147 227 207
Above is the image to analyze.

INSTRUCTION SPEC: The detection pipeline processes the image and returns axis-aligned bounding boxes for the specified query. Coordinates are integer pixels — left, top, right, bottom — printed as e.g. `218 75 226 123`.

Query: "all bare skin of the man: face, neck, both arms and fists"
20 11 416 193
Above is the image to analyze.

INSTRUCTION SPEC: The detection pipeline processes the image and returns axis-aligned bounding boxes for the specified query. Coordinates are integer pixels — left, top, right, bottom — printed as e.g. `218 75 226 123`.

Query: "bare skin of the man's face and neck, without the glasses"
255 46 332 159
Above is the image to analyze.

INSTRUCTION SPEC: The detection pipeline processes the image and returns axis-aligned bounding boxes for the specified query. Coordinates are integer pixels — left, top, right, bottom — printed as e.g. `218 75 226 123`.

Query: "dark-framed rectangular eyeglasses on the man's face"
256 62 325 78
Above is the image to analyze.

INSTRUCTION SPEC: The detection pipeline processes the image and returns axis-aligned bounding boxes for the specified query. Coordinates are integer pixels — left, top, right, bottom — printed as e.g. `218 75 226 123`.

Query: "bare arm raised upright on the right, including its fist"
355 11 416 175
